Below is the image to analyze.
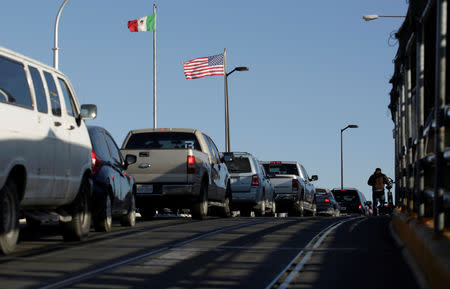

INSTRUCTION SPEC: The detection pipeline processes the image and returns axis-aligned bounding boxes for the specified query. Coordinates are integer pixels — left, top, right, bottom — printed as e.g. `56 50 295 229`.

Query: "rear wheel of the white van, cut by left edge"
0 181 19 255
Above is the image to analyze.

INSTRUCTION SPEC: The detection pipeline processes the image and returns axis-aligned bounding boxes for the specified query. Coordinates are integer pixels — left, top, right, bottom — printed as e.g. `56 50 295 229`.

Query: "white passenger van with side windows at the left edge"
0 47 97 254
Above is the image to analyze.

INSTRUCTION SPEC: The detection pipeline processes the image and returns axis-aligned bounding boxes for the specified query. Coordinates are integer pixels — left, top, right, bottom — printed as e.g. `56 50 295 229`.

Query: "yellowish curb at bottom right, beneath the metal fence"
392 210 450 289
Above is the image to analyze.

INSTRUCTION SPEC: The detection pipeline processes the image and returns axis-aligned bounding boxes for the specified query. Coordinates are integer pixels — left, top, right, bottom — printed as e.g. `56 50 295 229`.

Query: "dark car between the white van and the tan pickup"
88 126 136 232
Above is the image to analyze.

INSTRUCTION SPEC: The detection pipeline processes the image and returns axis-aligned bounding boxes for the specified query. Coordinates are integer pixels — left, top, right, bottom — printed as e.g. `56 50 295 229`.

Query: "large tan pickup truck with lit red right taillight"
121 128 231 219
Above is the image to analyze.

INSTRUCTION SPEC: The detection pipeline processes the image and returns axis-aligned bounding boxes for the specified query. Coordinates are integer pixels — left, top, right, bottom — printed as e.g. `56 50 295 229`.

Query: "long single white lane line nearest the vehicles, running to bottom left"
40 220 268 289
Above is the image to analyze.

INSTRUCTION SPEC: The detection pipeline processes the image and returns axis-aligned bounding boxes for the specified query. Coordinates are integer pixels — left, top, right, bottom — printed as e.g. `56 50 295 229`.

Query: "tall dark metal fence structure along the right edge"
389 0 450 235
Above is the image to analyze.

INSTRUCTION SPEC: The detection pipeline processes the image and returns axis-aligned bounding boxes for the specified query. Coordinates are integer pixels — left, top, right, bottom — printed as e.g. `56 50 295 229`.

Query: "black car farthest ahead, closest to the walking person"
331 188 369 215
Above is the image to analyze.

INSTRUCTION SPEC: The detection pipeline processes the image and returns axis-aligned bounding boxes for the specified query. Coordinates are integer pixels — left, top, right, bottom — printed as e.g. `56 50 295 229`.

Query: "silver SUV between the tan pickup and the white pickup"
225 152 276 216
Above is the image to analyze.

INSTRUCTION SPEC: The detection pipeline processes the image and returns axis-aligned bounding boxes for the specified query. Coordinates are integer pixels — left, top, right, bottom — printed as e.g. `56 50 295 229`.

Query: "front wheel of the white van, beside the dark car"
61 177 92 241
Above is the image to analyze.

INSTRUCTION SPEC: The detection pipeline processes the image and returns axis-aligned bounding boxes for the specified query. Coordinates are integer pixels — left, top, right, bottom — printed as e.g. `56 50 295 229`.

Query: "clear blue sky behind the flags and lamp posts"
0 0 408 199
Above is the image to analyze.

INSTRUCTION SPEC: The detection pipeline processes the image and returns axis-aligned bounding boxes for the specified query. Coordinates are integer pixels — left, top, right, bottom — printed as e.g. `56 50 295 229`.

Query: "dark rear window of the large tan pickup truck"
125 132 201 150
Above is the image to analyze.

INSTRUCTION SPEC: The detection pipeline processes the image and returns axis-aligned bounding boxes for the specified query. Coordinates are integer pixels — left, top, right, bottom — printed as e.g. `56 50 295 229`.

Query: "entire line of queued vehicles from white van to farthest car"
0 47 365 254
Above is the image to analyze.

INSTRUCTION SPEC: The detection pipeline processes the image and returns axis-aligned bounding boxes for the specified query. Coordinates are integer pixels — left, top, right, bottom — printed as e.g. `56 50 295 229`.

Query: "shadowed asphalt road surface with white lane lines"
0 216 418 289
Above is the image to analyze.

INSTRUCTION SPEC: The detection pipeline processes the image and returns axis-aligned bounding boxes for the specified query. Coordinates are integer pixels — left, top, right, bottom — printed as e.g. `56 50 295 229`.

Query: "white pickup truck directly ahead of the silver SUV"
262 161 318 216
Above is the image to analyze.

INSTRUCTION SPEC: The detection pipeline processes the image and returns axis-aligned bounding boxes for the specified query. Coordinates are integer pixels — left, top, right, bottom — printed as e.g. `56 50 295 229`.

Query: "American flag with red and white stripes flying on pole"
183 54 224 79
